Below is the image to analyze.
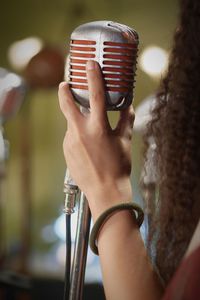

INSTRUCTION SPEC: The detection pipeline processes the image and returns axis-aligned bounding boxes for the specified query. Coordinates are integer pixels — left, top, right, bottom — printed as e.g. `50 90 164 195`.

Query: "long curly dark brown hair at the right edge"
145 0 200 283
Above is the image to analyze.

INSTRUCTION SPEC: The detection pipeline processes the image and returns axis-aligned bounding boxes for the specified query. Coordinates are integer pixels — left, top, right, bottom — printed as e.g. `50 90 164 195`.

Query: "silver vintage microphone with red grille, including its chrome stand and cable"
64 21 139 300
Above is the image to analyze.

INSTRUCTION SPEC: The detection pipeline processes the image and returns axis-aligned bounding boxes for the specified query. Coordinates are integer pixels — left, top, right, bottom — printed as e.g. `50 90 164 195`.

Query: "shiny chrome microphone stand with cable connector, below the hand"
64 107 91 300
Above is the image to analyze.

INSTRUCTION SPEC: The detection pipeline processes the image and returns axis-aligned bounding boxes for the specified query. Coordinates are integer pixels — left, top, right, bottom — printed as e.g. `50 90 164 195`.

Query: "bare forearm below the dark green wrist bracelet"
90 191 162 300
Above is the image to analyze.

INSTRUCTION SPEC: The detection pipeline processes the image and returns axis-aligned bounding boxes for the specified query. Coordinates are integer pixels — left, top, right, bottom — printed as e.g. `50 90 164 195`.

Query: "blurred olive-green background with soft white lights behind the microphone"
0 0 178 299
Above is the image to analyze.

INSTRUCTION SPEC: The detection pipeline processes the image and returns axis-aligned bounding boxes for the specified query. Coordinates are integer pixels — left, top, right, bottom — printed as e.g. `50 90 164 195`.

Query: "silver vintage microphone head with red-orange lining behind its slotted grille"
67 21 139 110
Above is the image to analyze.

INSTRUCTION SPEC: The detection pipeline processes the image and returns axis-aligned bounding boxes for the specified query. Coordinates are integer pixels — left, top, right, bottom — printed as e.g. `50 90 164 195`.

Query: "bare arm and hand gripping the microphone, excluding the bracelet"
59 63 162 300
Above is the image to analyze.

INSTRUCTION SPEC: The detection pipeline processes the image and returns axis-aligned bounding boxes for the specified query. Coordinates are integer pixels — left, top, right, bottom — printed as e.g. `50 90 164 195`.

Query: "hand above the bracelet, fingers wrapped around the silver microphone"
59 62 134 218
